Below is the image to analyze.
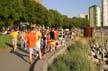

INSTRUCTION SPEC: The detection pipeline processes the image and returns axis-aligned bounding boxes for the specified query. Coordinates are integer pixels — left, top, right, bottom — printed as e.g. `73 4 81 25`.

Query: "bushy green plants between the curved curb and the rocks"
48 42 96 71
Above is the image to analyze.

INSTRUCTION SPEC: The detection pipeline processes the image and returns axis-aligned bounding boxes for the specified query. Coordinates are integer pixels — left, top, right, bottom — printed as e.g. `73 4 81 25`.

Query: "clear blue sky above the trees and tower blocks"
42 0 101 17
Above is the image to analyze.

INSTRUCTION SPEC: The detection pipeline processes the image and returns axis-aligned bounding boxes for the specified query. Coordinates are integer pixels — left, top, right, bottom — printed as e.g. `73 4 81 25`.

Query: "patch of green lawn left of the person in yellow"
0 35 11 48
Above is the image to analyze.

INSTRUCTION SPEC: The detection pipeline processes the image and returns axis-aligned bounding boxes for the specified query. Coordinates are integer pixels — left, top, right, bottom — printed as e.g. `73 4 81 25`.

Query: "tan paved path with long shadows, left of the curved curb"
0 48 36 71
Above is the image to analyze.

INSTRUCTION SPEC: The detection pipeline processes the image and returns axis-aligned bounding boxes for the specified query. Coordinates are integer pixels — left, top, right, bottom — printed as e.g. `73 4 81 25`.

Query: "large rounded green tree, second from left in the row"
22 0 48 25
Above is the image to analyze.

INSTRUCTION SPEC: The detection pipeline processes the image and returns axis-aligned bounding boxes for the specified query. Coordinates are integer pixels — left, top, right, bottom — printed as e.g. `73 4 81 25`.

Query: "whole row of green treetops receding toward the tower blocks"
0 0 88 28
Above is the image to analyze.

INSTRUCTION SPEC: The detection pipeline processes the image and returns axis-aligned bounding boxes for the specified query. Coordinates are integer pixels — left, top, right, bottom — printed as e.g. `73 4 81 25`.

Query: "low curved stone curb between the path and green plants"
34 40 72 71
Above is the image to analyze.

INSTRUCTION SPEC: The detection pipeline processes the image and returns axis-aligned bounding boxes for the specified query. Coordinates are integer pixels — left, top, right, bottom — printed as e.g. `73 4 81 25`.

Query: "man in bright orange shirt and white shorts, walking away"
25 28 36 64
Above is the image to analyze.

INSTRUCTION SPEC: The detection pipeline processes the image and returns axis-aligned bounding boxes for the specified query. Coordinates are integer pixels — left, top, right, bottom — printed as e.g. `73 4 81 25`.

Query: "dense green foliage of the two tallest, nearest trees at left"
0 0 47 26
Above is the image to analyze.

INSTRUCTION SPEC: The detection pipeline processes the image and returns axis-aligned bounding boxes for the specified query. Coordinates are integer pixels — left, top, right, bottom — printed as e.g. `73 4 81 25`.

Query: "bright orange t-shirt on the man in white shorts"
25 32 36 48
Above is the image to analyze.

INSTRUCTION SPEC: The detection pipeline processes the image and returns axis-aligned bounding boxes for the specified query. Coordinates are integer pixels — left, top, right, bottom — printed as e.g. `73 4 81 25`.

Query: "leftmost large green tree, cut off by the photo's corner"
0 0 24 26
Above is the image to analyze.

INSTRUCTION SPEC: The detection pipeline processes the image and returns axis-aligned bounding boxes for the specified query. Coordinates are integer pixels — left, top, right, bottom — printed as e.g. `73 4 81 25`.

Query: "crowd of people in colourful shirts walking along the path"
10 25 65 64
